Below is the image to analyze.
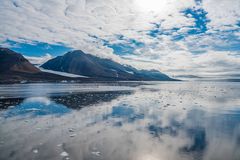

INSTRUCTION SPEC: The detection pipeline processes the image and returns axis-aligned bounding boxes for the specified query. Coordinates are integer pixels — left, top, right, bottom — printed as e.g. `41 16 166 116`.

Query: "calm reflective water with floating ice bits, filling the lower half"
0 82 240 160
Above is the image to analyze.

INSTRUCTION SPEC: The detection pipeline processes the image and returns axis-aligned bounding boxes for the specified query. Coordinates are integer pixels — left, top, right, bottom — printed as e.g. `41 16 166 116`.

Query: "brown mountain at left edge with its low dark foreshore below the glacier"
0 48 90 83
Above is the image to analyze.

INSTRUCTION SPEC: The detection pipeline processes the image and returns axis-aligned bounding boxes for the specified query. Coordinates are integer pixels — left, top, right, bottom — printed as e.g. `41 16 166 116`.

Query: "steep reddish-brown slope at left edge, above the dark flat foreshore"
0 48 40 73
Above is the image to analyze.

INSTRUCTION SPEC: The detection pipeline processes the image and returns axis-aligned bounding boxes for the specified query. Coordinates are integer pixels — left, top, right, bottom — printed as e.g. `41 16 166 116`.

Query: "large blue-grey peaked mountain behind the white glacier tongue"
41 50 174 81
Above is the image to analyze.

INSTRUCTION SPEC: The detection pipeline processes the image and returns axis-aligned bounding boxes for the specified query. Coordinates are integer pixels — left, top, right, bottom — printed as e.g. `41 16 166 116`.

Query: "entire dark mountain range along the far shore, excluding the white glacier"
0 48 174 83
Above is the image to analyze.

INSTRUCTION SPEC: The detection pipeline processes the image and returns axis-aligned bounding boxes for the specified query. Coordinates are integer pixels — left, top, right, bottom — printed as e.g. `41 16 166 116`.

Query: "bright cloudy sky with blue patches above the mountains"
0 0 240 78
